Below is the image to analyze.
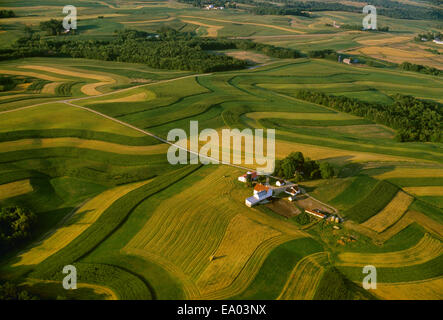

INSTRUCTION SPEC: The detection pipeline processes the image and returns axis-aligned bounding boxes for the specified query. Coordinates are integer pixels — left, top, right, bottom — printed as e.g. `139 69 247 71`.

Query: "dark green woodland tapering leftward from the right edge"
296 90 443 142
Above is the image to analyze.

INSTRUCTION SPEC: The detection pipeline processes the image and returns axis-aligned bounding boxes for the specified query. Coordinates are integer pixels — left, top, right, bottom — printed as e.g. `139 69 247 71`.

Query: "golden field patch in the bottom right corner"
372 278 443 300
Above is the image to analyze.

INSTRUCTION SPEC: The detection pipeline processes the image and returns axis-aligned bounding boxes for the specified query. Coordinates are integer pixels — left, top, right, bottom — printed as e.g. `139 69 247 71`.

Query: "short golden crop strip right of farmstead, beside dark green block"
363 191 414 232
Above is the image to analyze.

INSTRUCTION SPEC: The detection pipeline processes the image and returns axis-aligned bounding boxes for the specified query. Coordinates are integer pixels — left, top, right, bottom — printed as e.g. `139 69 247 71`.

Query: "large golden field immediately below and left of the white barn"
126 167 247 279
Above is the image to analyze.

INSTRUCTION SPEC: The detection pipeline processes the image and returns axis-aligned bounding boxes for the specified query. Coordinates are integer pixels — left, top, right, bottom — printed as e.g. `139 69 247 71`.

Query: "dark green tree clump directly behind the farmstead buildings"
274 152 334 182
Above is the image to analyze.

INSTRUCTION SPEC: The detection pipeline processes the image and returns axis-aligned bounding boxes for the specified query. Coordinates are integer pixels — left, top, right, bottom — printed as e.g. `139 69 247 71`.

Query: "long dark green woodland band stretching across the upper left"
0 28 301 72
